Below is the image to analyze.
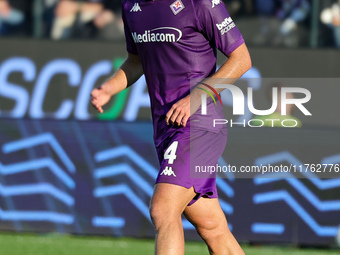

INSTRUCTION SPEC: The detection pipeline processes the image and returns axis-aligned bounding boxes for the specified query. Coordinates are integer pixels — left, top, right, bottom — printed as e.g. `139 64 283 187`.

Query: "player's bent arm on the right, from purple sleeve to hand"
165 0 252 127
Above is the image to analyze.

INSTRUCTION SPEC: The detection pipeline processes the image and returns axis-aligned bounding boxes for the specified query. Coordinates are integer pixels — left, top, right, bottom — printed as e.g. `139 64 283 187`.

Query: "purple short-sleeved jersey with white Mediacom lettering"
122 0 244 146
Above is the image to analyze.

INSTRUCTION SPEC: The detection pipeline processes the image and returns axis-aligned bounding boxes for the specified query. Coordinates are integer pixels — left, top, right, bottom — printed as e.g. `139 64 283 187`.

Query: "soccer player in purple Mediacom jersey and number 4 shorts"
91 0 251 255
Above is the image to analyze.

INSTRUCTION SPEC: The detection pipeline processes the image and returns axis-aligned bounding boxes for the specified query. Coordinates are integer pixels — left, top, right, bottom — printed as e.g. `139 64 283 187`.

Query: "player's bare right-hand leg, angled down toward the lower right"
184 198 244 255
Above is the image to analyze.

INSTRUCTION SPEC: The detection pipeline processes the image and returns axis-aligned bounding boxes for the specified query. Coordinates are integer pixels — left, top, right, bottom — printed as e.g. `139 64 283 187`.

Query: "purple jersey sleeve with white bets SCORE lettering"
194 0 244 56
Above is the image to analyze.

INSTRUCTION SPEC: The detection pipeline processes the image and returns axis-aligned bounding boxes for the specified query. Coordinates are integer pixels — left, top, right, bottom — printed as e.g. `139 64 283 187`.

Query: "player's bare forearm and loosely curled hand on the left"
91 53 143 113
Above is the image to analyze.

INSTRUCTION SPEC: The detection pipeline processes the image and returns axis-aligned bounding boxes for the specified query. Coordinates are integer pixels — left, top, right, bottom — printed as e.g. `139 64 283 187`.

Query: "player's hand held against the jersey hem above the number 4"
165 95 190 127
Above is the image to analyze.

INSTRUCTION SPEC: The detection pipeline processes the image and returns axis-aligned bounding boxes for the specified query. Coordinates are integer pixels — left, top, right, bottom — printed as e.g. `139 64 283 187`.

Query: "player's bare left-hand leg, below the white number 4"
150 183 195 255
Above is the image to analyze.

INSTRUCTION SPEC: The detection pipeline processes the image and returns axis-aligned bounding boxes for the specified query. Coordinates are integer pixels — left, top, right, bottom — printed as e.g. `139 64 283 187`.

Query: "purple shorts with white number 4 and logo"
156 128 227 205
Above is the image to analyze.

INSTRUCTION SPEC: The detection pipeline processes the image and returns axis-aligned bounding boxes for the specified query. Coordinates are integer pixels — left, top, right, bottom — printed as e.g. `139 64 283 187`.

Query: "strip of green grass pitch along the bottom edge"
0 233 340 255
